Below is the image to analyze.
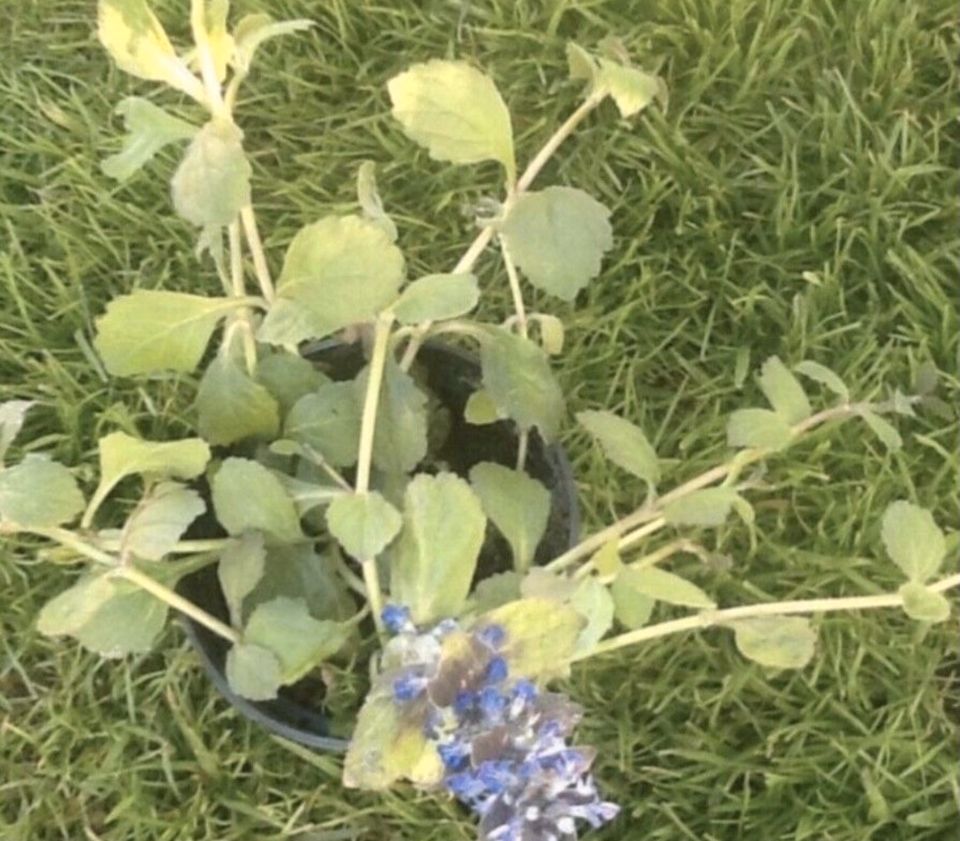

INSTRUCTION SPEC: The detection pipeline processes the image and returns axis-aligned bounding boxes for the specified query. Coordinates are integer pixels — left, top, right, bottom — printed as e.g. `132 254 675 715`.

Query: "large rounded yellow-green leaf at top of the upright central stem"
259 216 404 347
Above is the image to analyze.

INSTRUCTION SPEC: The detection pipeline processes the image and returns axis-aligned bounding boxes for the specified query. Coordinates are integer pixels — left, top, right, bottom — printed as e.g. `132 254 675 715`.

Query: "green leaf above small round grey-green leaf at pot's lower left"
243 597 349 684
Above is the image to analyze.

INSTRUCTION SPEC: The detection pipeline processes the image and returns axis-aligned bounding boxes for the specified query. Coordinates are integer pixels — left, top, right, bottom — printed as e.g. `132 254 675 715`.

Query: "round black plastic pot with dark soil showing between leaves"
177 343 580 752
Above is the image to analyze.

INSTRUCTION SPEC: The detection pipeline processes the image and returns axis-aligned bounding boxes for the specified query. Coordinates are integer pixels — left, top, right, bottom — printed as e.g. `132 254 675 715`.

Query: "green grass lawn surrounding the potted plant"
0 0 960 841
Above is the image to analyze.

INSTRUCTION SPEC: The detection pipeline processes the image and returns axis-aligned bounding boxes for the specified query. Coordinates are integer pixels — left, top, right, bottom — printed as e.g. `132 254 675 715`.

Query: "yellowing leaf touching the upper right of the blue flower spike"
474 598 584 679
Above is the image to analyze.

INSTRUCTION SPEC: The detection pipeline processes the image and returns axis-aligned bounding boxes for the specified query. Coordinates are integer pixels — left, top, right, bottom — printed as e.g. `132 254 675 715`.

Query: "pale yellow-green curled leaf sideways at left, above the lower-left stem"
96 432 210 497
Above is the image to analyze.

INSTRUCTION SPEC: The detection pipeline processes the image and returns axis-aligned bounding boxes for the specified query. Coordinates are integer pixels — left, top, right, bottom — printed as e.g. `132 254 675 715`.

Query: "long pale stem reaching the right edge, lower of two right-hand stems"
574 575 960 660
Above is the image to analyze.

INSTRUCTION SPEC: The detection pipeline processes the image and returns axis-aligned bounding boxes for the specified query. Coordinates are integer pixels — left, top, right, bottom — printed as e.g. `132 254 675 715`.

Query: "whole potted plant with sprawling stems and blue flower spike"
0 0 960 841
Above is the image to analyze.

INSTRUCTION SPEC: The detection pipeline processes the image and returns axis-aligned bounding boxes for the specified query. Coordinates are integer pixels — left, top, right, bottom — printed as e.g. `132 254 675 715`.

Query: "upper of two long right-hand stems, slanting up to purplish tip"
546 403 863 571
